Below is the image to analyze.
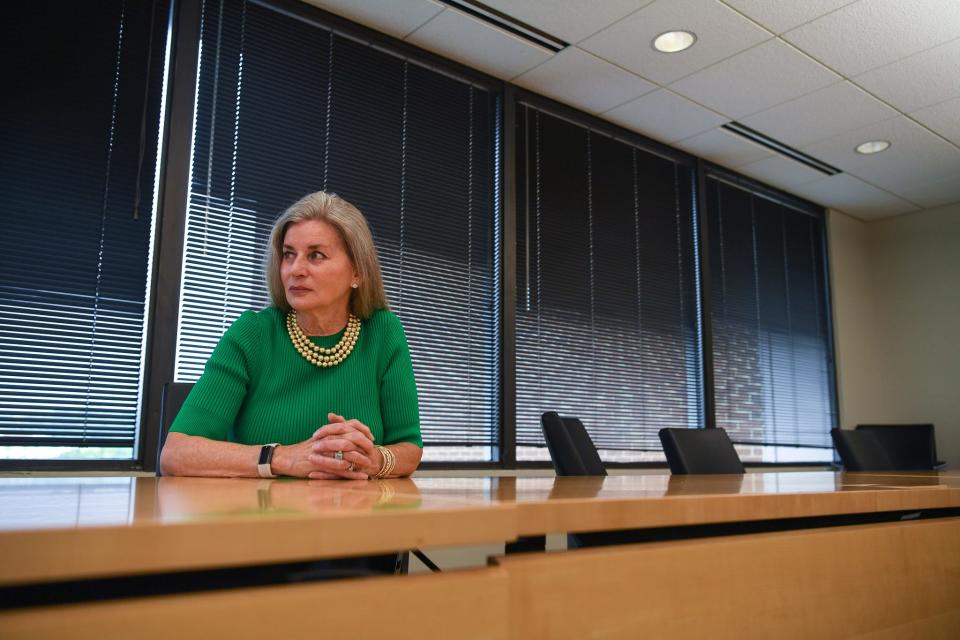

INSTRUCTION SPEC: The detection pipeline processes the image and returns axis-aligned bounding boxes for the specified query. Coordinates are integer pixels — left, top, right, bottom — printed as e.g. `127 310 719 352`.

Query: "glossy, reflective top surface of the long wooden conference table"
0 471 960 533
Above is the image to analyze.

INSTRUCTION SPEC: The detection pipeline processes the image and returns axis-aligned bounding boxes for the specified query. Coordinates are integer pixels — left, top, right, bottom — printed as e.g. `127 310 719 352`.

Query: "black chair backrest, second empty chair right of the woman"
660 428 744 473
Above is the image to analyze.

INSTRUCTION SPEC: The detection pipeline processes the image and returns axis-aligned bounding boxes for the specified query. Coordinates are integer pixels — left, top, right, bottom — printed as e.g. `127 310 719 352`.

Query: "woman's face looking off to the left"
280 220 357 313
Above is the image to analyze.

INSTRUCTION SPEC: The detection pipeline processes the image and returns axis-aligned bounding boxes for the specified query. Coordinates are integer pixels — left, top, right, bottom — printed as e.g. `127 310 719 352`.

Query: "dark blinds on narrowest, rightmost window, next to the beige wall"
706 178 836 459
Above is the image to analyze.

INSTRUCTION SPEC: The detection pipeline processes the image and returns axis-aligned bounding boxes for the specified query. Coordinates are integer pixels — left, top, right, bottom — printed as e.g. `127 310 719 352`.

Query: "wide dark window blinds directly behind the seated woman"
176 1 500 459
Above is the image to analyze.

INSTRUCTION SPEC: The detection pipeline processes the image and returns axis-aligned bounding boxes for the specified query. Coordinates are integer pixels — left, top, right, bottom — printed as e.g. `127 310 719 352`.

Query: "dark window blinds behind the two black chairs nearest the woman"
516 106 703 461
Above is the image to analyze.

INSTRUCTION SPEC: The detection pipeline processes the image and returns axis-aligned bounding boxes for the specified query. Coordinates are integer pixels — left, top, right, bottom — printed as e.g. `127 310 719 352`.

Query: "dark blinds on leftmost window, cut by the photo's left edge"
0 0 168 447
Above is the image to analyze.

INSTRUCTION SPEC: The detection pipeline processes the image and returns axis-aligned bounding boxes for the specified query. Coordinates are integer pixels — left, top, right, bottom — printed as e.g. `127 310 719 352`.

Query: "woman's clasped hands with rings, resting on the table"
272 413 383 480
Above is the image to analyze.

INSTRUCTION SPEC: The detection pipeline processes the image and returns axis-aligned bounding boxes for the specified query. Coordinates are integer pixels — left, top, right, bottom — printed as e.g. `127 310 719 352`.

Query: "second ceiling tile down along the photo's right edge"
853 37 960 111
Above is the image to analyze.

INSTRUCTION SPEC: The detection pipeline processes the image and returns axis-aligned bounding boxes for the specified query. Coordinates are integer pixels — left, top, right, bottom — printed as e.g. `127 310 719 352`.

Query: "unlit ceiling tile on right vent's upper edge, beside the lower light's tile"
741 80 898 147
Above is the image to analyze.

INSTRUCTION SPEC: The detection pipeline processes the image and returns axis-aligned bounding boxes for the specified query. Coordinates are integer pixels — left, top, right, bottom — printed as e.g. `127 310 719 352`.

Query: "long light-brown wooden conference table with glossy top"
0 471 960 639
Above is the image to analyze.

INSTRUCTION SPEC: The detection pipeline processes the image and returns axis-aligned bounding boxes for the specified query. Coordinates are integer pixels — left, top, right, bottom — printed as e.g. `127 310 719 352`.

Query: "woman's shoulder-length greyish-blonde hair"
265 191 390 320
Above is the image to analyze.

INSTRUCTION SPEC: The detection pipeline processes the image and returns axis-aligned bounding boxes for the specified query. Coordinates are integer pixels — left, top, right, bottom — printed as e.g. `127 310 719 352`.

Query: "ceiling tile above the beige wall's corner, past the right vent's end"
789 173 919 220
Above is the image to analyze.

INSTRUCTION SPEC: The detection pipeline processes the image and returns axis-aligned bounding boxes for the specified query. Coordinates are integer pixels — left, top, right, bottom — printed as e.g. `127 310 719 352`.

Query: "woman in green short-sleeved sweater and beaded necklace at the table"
160 192 423 479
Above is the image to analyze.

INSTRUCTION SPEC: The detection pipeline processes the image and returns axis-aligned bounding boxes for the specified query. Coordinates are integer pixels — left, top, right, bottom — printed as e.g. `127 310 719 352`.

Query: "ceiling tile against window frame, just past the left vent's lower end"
514 47 657 113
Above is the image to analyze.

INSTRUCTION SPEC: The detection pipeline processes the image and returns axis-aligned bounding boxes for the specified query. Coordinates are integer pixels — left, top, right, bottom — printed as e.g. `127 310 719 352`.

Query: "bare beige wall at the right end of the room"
829 204 960 468
